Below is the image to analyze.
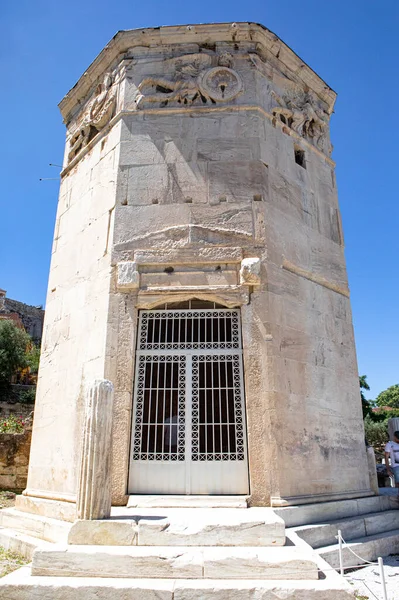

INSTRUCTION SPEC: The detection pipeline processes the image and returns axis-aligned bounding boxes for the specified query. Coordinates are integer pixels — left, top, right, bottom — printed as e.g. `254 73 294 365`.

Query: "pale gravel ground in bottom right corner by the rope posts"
345 554 399 600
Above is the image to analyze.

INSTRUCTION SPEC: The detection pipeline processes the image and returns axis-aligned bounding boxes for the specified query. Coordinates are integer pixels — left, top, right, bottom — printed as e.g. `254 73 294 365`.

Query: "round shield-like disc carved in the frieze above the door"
198 67 242 102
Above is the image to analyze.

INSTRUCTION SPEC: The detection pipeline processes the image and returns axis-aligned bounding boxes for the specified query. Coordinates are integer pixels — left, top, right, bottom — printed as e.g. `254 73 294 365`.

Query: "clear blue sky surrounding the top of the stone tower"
0 0 399 398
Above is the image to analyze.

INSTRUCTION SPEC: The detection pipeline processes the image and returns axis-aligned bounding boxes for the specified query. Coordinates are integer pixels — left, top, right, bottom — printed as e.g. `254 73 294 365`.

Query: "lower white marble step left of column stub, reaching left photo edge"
0 508 71 543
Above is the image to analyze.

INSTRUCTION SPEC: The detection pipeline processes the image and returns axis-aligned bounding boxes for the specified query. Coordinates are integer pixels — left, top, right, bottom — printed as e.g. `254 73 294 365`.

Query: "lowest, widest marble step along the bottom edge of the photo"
0 567 353 600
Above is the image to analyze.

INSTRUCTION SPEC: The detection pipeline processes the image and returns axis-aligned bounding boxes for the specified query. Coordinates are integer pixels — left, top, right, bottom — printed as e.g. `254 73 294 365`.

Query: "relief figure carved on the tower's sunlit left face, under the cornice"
68 73 116 162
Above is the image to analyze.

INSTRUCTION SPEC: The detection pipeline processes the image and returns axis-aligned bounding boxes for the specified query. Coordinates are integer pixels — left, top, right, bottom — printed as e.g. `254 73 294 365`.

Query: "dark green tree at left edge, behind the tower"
0 319 32 392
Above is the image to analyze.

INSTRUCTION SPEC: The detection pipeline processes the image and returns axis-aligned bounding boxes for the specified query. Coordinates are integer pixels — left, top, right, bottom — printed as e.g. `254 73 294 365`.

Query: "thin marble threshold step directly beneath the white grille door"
127 494 248 508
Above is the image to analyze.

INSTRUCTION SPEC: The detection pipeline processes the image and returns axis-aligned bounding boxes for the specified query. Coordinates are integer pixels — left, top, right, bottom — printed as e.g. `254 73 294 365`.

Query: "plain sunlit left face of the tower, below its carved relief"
24 115 120 501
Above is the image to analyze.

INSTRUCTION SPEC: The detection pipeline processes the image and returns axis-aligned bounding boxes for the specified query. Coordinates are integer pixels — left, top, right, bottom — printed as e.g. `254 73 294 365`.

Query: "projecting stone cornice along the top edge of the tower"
59 23 336 121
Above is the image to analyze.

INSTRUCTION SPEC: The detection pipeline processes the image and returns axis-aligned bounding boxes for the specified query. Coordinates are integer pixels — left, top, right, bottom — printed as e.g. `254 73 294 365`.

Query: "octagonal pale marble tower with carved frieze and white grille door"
24 23 373 512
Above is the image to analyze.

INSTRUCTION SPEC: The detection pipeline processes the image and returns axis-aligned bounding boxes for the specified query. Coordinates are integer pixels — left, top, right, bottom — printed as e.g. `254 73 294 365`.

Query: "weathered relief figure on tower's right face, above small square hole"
272 91 332 156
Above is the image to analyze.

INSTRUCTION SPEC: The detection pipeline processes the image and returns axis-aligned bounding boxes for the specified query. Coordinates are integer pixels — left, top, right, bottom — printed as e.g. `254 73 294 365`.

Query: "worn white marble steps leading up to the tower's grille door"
0 507 352 600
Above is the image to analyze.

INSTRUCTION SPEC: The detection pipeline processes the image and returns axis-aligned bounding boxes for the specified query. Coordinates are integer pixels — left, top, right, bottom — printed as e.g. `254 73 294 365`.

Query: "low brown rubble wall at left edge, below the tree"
0 429 32 490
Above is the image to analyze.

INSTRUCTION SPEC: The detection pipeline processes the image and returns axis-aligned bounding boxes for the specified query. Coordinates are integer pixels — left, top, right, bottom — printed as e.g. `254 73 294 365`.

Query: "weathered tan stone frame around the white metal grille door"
105 286 275 506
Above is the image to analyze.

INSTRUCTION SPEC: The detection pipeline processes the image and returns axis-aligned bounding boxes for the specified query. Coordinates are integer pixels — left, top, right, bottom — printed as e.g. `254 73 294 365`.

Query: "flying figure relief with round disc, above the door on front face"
136 52 242 108
